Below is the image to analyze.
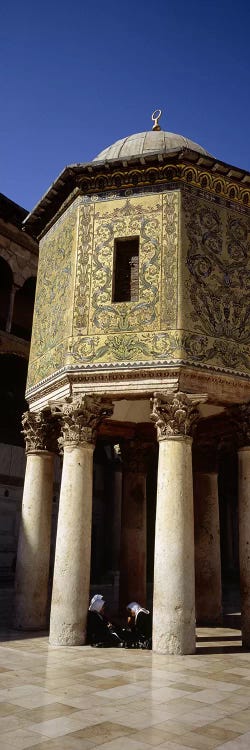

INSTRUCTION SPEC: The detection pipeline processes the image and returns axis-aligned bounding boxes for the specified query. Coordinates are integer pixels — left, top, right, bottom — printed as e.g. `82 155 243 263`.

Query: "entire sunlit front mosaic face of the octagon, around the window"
67 191 180 364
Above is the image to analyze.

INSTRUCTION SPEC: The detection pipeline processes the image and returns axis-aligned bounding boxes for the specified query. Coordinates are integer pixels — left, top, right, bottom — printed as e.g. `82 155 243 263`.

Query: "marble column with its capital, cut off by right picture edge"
231 402 250 649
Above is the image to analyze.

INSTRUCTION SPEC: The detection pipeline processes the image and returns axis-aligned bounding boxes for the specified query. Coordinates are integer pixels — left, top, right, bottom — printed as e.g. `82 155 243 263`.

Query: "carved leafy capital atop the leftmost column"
22 408 57 453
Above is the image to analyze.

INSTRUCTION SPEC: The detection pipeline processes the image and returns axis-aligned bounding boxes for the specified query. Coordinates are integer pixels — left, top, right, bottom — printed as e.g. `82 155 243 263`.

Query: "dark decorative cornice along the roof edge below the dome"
24 150 250 238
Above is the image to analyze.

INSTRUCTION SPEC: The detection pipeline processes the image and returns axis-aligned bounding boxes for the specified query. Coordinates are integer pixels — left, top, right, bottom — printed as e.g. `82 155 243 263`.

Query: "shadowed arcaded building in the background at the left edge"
0 194 38 586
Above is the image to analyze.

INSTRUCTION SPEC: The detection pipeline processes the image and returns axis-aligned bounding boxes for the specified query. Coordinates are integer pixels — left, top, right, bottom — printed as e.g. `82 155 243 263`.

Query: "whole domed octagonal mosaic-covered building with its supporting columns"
13 118 250 653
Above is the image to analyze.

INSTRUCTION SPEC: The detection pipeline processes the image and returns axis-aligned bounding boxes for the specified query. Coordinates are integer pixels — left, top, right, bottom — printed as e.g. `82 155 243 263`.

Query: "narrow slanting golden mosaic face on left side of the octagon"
27 205 77 388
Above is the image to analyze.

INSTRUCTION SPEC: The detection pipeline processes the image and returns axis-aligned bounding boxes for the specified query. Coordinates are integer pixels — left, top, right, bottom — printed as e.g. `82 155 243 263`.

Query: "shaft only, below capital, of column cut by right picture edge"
238 445 250 648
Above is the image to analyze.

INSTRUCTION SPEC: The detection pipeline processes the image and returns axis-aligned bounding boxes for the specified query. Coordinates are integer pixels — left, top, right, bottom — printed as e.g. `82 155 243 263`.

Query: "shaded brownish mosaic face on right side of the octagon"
182 195 250 372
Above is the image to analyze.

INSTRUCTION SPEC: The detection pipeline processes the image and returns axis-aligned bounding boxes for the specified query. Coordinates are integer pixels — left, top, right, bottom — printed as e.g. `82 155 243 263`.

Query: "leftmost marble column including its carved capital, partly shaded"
14 410 54 630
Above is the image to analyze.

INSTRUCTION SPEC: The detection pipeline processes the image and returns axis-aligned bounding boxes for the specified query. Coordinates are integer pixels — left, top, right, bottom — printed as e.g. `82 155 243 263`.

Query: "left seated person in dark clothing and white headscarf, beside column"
87 594 123 647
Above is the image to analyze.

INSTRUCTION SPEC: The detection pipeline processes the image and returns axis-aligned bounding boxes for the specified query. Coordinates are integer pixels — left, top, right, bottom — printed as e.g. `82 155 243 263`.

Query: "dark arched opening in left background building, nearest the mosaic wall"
11 276 36 341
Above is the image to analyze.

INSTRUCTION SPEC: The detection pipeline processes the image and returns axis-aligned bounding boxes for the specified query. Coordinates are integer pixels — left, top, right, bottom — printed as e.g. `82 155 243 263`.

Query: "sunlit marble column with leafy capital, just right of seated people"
151 393 205 654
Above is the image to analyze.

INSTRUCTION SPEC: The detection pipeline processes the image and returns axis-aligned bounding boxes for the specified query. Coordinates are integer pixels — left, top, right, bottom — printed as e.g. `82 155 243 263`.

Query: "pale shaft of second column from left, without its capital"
50 442 94 646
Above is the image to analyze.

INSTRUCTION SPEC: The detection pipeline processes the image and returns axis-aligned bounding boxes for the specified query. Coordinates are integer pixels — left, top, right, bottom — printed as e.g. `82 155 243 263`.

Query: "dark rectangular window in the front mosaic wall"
112 237 139 302
